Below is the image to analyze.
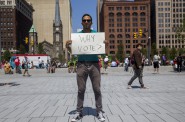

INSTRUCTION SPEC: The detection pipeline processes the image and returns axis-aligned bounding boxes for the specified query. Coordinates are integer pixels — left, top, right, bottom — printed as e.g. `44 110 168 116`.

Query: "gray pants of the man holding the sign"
77 63 102 112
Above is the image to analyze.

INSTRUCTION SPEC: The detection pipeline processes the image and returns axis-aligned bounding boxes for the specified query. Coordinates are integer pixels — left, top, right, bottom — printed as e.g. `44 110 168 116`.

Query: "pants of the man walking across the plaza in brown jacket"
128 69 144 87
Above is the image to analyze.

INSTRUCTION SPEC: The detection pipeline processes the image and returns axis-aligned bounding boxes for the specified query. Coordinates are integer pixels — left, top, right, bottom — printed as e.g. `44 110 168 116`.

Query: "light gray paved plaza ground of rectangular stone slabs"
0 66 185 122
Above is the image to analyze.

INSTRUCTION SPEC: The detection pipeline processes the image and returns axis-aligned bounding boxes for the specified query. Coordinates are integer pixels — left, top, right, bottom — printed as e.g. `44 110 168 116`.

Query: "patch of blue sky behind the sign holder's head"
71 0 97 32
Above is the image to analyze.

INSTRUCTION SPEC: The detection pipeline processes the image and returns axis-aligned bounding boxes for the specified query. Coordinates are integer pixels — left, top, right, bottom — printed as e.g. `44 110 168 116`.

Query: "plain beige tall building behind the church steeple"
27 0 72 50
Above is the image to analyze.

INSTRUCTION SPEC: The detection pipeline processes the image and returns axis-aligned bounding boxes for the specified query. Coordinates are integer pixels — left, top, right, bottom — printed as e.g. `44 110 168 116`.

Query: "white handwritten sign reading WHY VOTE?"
71 33 105 54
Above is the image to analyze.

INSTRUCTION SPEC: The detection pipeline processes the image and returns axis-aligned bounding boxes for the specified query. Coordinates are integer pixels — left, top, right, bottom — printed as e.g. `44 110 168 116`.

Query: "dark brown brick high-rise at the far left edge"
0 0 34 53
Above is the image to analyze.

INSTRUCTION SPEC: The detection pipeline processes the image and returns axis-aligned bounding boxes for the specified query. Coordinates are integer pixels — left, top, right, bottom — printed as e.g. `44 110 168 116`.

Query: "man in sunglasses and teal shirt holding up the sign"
66 14 105 122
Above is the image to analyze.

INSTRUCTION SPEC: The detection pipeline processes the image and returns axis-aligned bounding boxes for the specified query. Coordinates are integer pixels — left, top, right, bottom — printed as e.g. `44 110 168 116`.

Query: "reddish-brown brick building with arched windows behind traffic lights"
98 0 151 57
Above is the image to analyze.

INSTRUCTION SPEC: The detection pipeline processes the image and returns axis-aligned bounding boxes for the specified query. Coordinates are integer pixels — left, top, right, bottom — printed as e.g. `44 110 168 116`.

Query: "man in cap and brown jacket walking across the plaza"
128 43 147 89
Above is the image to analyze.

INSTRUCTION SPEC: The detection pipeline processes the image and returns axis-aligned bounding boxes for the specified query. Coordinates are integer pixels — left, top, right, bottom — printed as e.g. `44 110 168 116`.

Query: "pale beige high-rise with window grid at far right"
155 0 185 51
